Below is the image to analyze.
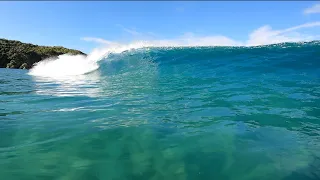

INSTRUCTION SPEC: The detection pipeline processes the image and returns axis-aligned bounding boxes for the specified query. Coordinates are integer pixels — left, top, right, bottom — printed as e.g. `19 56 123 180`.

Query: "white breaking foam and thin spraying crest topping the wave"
28 41 320 78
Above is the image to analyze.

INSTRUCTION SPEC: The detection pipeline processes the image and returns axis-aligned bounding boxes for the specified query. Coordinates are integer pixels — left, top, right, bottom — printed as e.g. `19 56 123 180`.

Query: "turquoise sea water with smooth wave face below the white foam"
0 42 320 180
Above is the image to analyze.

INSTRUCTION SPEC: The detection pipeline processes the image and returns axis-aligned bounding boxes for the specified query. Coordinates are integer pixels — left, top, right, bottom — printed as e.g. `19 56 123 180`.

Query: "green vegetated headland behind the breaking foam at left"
0 39 86 69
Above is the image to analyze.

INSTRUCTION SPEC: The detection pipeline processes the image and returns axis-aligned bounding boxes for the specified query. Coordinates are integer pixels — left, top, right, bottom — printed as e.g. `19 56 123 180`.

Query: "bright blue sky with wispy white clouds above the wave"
0 1 320 53
